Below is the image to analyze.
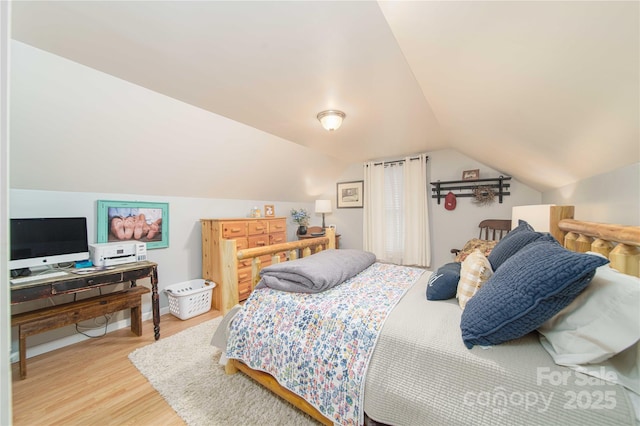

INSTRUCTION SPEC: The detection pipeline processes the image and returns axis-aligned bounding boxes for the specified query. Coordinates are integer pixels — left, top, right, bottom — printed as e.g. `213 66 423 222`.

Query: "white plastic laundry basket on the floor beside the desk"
164 278 216 320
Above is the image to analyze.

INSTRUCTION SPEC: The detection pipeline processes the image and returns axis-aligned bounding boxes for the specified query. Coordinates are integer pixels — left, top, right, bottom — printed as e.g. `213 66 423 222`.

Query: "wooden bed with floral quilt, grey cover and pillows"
212 215 640 425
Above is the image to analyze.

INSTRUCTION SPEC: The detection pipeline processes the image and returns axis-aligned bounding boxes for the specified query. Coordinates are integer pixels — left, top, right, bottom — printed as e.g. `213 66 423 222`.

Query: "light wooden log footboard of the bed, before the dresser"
220 228 336 314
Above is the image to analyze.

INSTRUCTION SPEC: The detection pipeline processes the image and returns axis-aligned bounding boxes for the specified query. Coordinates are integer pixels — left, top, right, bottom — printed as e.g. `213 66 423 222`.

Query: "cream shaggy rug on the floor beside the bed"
129 318 318 426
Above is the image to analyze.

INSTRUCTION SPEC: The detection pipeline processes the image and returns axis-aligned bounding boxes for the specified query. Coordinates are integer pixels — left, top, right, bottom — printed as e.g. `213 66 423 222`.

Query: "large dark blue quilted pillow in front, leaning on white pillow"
460 241 609 349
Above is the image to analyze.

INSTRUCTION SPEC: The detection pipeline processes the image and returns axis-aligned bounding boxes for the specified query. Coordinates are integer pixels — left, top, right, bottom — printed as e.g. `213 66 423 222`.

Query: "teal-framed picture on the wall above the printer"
97 200 169 249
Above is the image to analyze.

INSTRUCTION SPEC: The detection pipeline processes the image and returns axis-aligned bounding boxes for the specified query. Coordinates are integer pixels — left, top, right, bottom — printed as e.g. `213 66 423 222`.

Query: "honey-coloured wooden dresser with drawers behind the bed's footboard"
200 217 287 310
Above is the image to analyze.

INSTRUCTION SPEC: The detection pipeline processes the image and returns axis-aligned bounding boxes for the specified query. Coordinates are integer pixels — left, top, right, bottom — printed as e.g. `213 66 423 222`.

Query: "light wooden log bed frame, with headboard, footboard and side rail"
223 215 640 425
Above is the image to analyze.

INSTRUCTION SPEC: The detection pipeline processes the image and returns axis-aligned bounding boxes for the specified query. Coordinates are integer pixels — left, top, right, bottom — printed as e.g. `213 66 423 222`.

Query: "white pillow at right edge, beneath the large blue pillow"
538 265 640 365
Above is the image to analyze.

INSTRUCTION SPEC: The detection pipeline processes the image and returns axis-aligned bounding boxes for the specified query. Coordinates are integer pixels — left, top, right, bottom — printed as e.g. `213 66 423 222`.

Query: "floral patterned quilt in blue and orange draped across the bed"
227 263 424 425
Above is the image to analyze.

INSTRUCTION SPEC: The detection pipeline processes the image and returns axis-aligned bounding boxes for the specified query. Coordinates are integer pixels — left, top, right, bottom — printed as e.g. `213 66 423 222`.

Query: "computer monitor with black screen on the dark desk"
9 217 89 271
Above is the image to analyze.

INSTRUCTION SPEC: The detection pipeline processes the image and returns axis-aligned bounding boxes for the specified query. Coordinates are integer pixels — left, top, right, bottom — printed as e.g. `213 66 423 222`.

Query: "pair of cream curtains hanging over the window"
363 154 431 267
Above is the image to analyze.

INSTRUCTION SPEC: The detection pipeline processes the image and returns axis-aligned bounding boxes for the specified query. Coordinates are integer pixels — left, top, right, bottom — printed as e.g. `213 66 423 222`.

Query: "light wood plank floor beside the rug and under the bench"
12 310 220 426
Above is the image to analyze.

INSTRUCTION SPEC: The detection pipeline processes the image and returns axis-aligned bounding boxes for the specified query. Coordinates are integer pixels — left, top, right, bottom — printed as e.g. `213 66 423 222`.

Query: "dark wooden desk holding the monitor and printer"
11 262 160 340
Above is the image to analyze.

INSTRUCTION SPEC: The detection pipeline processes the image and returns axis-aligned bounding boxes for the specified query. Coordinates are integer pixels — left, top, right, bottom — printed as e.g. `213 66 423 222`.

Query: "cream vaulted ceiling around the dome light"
7 1 640 191
